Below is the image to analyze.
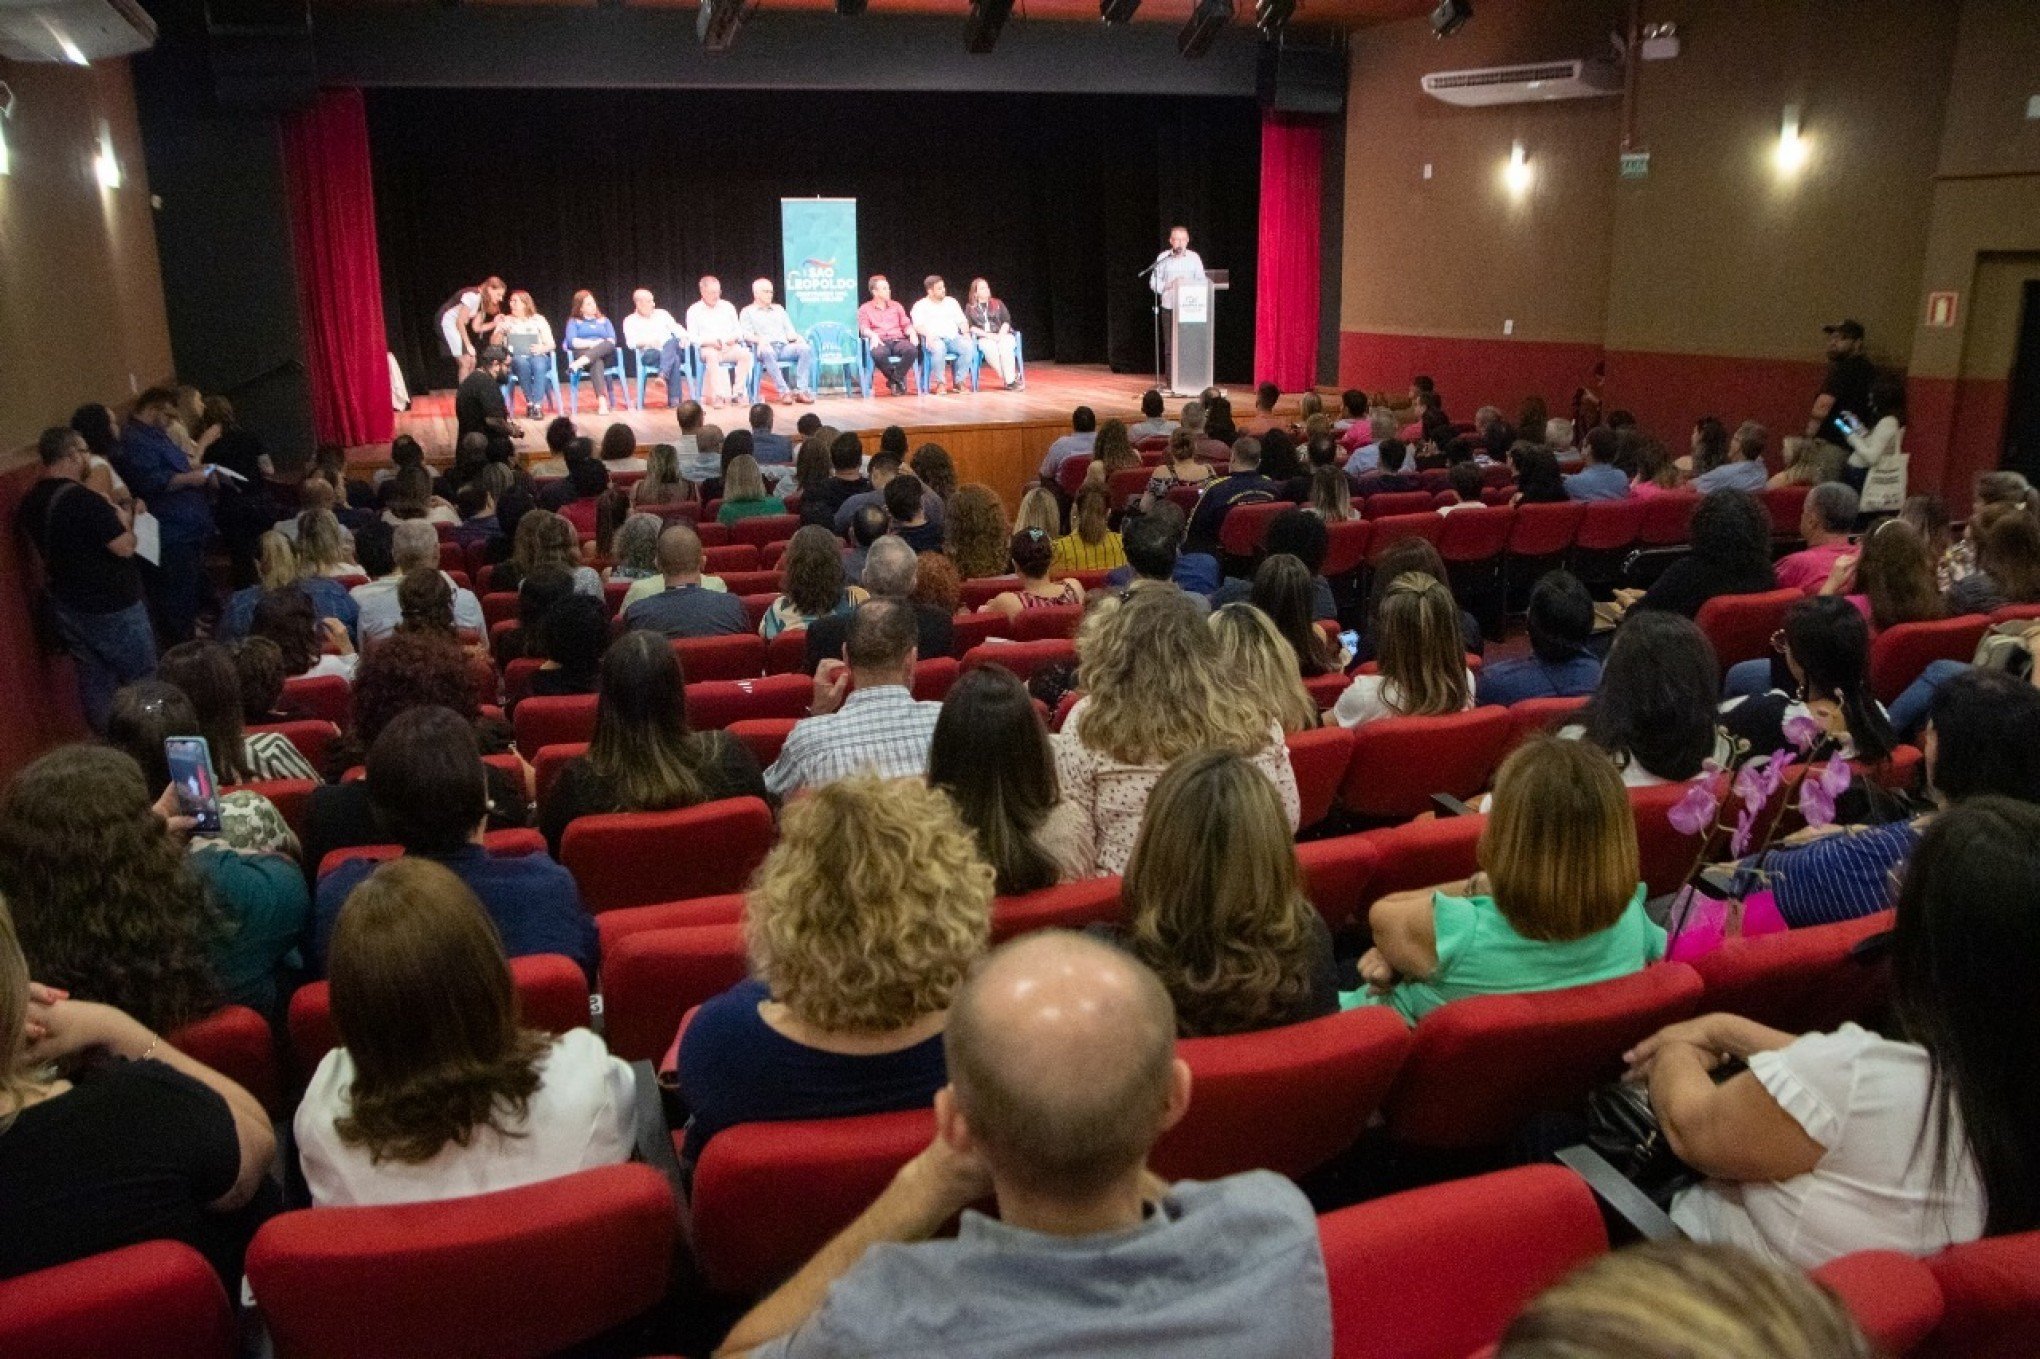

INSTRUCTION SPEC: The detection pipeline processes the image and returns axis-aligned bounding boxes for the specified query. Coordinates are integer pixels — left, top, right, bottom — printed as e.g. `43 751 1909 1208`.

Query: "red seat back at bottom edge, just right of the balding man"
1318 1165 1608 1359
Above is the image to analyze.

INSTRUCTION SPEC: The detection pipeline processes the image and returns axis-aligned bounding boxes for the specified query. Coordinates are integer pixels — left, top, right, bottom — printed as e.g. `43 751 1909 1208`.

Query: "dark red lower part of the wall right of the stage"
1338 331 2005 490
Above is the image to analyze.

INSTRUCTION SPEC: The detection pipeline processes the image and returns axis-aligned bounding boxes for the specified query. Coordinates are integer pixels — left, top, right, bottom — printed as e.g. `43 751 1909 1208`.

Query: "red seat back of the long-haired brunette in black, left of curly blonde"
559 798 775 914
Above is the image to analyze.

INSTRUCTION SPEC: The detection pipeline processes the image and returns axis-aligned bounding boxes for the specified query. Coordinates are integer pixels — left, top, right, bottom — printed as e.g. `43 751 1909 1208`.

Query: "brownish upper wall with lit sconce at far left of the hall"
0 61 171 459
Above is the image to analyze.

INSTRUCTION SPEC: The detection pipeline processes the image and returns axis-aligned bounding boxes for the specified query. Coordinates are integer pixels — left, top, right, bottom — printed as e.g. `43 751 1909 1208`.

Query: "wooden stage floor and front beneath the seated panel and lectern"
375 363 1199 504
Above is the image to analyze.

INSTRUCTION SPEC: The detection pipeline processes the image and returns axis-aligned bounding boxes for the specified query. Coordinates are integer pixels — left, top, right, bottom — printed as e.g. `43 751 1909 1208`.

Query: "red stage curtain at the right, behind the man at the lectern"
1255 112 1324 392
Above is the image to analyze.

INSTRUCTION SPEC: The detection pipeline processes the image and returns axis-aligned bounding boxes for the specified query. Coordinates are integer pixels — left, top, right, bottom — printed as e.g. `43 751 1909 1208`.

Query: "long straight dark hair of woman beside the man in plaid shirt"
928 665 1065 896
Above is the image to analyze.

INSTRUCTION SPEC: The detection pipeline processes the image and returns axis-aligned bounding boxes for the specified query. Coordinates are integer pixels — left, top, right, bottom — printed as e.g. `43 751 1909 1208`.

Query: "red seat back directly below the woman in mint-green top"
1387 963 1701 1151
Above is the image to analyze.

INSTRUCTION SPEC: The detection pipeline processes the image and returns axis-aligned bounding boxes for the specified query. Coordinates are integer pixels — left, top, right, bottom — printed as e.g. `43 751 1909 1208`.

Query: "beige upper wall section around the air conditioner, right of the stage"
1340 0 1626 343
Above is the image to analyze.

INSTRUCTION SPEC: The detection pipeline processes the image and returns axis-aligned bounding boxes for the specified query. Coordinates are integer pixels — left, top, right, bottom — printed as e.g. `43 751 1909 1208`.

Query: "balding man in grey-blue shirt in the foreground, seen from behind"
718 933 1332 1359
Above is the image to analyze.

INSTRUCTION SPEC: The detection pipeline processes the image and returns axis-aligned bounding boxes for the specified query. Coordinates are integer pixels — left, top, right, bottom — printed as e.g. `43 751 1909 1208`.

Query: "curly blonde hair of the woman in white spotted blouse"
1075 582 1269 765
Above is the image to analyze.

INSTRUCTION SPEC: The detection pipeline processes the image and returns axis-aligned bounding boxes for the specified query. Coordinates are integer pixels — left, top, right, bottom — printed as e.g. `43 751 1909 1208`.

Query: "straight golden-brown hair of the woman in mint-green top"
1479 737 1642 943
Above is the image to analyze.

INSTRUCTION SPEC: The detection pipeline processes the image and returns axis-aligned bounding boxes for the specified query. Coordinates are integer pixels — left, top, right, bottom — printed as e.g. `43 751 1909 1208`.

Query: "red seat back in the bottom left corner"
0 1241 241 1359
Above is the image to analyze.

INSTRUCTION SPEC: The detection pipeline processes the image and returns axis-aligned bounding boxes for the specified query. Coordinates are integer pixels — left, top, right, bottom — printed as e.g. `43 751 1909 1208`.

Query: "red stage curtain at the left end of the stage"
284 90 396 445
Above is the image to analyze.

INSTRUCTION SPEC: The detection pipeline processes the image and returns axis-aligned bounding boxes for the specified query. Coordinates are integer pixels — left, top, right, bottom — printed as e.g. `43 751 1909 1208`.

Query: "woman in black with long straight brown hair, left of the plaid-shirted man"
539 633 771 855
